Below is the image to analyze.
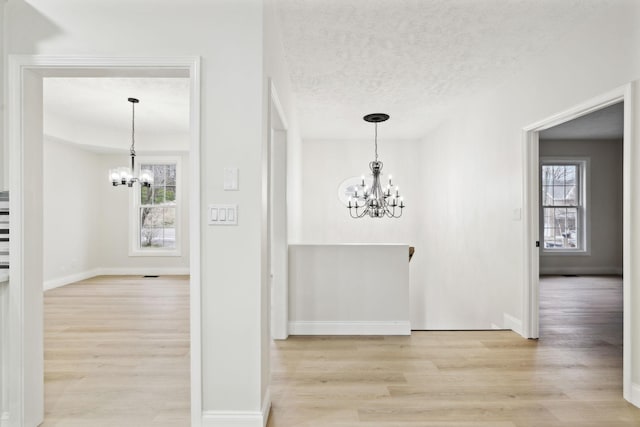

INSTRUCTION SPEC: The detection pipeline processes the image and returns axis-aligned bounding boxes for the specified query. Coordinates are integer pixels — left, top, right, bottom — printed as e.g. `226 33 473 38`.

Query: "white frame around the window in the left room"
129 156 184 257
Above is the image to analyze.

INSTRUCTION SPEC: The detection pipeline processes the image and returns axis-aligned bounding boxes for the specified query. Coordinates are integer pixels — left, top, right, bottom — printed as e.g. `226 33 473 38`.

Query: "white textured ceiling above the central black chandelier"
278 0 611 138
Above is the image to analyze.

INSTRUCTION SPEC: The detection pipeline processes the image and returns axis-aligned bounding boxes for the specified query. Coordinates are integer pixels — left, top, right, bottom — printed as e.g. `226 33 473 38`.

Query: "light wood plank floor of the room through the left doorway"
42 276 190 427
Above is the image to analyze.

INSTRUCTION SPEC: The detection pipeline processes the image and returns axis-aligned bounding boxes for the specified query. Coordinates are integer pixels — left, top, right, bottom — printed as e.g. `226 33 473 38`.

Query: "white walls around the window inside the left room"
43 142 189 289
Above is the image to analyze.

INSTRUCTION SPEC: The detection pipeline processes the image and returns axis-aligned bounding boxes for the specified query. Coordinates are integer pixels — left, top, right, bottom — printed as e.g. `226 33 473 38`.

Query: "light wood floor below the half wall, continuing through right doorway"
268 277 640 427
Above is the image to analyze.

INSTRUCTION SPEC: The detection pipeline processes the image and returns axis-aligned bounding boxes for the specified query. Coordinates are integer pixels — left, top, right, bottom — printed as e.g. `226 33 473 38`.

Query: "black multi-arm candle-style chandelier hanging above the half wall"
347 113 405 218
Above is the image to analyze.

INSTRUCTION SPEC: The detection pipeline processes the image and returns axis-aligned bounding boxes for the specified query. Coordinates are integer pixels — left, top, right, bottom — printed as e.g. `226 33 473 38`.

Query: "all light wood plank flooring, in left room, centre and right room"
43 277 640 427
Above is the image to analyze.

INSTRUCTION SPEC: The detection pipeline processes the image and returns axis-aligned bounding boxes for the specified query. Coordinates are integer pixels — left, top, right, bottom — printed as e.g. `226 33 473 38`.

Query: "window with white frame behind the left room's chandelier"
131 161 180 256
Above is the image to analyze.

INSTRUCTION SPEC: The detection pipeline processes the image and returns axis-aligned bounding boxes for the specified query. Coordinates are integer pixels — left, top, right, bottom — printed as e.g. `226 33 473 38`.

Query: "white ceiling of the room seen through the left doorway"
43 77 189 152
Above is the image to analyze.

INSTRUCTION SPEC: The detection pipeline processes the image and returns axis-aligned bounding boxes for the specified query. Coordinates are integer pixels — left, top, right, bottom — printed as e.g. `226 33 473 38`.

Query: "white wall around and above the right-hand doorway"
410 2 640 402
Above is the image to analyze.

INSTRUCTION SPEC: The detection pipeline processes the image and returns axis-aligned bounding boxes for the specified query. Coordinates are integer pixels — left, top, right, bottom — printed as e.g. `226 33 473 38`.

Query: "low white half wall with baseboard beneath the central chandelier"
289 244 411 335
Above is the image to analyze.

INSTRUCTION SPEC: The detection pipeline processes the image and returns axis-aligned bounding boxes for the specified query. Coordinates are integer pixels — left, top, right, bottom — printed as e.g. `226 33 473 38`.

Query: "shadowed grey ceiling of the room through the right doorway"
540 102 624 140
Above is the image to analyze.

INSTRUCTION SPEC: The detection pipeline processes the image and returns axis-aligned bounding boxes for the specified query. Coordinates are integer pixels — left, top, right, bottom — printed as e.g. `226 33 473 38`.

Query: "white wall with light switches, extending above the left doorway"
7 0 283 423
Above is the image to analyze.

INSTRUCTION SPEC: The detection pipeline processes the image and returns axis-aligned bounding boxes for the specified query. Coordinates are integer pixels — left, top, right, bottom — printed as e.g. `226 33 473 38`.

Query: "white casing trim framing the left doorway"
2 56 202 426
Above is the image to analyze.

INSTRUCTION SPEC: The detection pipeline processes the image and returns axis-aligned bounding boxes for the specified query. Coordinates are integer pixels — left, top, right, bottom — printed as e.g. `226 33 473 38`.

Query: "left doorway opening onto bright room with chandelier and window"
42 75 190 425
